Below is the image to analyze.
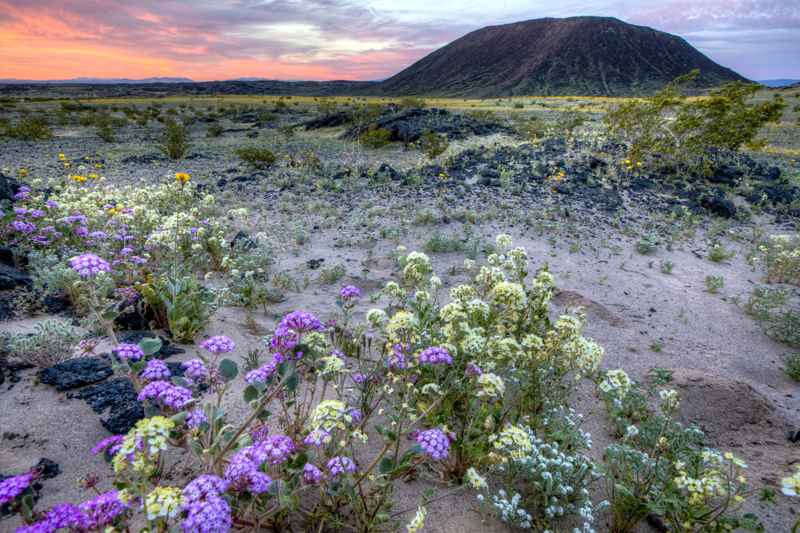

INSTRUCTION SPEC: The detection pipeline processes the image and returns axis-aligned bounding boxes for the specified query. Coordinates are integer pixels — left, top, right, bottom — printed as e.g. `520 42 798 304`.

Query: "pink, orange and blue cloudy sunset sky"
0 0 800 81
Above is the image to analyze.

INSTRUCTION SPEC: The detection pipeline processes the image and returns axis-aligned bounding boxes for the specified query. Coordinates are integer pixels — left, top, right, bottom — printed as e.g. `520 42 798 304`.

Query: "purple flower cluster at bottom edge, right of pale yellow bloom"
181 474 232 533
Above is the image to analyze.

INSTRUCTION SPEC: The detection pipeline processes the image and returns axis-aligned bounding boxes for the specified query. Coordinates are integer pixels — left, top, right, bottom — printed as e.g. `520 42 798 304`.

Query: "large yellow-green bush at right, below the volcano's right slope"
606 71 785 173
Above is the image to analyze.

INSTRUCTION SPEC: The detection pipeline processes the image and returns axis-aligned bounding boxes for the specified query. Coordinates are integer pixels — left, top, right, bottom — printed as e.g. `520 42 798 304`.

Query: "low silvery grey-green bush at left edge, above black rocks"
6 320 83 368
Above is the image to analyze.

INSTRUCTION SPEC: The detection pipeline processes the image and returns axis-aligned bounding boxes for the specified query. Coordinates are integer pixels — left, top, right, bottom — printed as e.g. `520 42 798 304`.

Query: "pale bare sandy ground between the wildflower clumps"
0 206 800 532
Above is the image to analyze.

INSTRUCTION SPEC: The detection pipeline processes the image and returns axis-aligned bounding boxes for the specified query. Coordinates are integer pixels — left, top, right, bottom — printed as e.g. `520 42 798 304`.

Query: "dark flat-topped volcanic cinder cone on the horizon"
379 17 745 97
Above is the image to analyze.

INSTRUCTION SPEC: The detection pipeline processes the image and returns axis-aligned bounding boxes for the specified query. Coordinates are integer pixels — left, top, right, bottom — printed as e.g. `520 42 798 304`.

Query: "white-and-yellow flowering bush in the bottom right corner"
598 370 763 533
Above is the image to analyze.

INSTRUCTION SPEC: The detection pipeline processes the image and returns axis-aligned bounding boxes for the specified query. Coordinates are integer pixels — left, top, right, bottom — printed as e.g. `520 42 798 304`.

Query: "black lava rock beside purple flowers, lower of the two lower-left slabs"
70 378 144 435
